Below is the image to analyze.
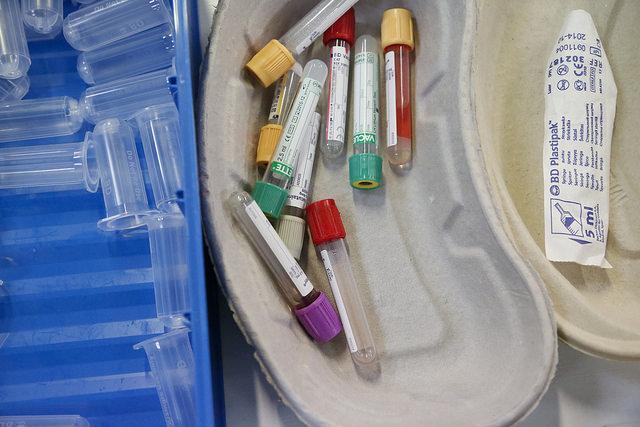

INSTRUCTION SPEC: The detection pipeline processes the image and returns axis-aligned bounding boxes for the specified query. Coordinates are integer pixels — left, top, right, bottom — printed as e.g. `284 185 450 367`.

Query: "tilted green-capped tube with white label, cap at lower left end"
253 59 327 219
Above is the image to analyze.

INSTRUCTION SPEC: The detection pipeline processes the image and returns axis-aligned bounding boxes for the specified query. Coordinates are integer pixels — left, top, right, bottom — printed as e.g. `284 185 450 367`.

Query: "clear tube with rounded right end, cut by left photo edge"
0 96 83 142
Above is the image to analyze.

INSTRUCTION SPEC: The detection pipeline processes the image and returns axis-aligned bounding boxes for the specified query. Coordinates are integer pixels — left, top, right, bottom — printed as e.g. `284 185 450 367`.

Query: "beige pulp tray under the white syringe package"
467 0 640 360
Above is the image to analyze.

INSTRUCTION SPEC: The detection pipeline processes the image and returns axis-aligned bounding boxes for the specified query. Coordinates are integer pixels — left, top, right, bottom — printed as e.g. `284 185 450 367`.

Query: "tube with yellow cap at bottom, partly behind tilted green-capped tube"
256 63 302 176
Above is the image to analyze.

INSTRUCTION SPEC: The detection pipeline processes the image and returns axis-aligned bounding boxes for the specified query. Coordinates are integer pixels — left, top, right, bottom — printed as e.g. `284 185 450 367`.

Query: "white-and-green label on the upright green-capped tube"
353 52 380 144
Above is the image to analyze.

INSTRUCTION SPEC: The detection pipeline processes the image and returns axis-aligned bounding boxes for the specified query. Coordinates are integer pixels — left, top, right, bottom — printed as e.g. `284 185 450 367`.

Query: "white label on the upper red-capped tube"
326 46 350 143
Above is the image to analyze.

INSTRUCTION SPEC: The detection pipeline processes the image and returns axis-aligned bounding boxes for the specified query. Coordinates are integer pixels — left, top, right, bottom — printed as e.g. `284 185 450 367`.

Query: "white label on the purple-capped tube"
244 201 313 297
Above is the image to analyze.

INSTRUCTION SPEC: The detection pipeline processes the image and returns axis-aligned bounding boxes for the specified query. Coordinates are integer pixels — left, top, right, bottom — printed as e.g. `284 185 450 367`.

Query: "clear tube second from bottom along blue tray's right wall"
146 212 191 327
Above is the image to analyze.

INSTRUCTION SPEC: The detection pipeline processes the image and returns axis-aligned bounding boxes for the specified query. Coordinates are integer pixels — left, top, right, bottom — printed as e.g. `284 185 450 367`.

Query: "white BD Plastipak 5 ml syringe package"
542 10 617 268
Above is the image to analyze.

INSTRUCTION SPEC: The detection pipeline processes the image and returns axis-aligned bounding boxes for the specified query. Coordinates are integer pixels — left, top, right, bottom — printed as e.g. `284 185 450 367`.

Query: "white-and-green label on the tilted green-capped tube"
271 77 322 178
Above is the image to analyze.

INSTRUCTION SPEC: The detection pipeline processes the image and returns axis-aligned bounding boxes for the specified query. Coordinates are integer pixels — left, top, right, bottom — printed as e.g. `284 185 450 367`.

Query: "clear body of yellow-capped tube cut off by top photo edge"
280 0 358 56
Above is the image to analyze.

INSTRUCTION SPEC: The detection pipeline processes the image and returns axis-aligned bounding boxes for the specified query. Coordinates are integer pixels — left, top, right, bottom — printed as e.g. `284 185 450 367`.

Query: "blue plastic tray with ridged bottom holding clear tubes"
0 1 223 427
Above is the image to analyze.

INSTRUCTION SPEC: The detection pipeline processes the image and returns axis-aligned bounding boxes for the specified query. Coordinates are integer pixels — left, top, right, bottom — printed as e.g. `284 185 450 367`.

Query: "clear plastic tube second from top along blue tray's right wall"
78 24 175 85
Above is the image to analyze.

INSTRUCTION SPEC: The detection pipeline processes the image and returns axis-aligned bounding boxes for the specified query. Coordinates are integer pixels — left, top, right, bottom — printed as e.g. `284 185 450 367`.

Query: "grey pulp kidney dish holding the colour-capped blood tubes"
199 0 556 426
